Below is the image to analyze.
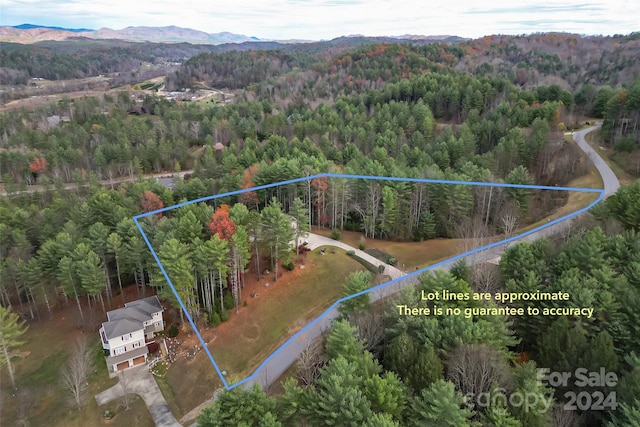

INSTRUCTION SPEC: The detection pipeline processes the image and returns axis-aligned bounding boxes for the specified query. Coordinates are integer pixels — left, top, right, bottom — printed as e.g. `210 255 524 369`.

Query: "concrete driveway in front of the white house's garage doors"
96 365 182 427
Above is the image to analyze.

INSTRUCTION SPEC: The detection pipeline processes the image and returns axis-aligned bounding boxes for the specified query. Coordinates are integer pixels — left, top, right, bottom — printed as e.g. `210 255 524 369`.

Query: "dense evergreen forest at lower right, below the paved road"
198 181 640 427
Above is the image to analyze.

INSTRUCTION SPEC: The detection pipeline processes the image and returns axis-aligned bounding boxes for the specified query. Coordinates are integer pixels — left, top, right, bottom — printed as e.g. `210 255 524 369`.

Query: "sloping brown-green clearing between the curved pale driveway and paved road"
209 249 363 383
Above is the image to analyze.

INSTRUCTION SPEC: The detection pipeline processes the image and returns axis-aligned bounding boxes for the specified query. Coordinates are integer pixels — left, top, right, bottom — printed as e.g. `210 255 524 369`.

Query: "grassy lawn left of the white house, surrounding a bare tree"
0 303 155 427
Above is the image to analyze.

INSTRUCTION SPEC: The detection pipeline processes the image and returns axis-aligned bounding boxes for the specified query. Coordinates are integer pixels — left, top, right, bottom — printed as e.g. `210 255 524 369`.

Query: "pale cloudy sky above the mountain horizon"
0 0 640 40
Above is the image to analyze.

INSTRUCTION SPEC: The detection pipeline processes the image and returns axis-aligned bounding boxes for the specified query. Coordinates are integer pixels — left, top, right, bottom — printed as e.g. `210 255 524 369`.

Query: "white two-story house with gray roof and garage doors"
100 295 164 373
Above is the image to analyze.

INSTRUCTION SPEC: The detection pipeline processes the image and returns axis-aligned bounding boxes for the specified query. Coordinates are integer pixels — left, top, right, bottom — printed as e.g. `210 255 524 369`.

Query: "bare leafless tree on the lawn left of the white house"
62 337 93 410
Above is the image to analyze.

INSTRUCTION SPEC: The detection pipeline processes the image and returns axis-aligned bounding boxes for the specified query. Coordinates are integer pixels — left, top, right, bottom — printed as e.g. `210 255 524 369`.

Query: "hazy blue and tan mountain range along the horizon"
0 24 463 45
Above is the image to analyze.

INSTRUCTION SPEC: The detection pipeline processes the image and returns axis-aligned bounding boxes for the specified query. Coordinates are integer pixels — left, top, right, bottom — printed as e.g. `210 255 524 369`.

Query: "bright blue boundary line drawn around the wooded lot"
133 173 604 390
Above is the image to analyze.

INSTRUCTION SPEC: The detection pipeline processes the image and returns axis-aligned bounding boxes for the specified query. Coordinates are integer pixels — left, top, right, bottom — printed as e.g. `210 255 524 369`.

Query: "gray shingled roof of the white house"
102 295 163 339
